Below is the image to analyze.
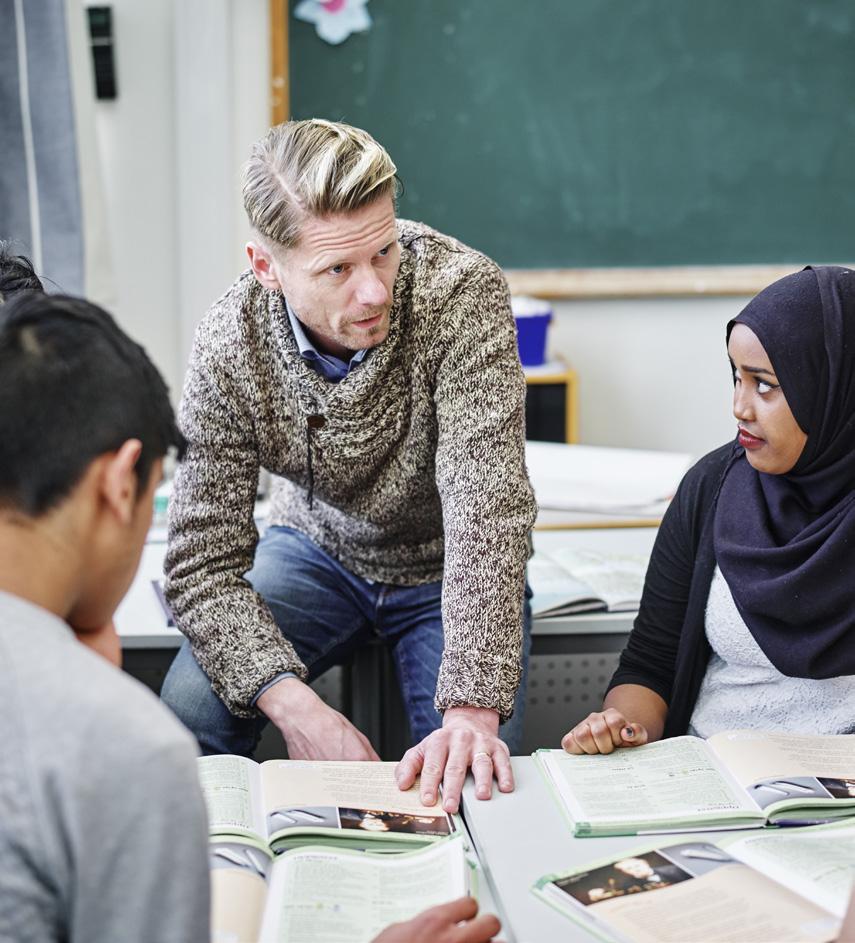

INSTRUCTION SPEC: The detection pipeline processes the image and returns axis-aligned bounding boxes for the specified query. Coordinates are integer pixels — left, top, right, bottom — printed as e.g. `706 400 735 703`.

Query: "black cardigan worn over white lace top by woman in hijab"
609 442 734 737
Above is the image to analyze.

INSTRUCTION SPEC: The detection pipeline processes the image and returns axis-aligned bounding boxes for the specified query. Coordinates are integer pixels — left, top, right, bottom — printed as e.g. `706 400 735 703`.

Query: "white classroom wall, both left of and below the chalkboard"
87 0 744 455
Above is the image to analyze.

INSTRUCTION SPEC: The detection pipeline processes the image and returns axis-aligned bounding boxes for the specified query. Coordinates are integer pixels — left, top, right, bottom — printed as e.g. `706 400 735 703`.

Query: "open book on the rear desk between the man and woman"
528 547 647 617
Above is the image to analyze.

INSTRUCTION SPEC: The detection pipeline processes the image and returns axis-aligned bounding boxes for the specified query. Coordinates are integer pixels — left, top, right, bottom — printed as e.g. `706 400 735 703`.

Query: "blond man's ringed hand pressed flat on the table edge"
395 707 514 812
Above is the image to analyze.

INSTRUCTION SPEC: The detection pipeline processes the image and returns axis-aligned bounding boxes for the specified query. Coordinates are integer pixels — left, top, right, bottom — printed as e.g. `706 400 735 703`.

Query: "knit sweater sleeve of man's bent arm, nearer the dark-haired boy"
165 324 306 717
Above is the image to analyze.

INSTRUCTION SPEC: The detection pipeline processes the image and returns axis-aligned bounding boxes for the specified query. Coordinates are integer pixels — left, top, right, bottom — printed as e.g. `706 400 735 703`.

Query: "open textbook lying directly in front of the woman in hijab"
535 730 855 837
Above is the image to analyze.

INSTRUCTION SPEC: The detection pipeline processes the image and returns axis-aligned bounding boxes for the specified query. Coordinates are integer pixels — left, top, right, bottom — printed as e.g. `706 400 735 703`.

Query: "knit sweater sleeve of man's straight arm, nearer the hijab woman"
434 265 536 720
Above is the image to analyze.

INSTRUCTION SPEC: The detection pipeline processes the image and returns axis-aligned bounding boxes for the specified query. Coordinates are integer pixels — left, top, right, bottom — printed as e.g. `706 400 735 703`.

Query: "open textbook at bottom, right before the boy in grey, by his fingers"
210 835 471 943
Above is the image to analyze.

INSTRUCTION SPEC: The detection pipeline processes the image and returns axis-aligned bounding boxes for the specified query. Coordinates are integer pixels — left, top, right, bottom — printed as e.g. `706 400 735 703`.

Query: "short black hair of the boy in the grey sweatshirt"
0 291 185 516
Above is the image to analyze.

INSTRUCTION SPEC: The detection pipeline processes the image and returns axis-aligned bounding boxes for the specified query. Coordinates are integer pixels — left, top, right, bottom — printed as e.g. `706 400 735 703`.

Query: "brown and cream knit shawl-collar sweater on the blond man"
166 220 535 719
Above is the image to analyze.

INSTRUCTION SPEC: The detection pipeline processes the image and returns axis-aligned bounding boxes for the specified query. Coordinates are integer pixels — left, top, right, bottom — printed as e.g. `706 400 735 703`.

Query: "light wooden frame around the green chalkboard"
269 0 855 299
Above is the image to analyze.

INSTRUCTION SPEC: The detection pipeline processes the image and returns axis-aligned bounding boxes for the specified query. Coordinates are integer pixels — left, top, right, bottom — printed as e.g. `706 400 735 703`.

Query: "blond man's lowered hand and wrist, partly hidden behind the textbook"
257 678 380 760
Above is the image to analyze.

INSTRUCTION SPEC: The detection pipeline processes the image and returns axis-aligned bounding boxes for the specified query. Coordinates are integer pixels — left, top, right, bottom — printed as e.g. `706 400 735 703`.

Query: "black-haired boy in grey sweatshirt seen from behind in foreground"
0 291 209 943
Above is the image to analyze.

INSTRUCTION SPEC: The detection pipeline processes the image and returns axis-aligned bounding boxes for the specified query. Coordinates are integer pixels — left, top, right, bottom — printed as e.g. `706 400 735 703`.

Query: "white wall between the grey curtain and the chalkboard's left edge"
90 0 269 400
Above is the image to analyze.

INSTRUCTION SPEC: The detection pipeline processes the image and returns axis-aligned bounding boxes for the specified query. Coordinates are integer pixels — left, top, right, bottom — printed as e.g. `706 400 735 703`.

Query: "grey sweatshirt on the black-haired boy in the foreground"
0 593 209 943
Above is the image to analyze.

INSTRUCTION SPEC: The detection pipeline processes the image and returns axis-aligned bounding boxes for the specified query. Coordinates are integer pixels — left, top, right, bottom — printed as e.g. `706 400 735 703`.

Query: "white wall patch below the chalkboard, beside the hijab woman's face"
549 298 747 456
